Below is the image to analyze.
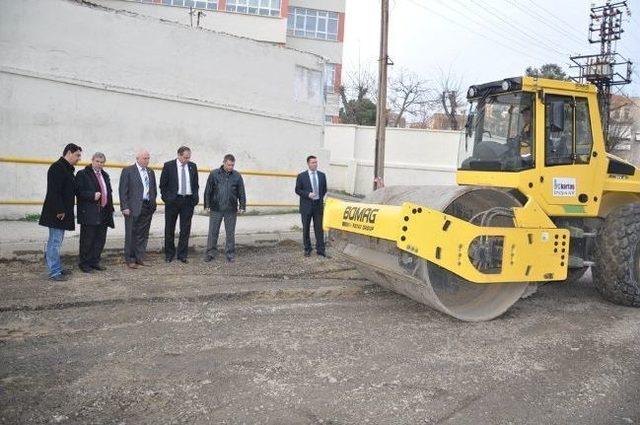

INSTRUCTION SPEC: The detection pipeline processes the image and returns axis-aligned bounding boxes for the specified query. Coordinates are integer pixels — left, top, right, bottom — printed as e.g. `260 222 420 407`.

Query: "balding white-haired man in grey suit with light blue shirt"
119 150 157 269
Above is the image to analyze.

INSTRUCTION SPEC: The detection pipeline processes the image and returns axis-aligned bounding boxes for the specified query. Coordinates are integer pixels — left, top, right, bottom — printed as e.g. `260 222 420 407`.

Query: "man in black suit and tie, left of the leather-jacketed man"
160 146 199 263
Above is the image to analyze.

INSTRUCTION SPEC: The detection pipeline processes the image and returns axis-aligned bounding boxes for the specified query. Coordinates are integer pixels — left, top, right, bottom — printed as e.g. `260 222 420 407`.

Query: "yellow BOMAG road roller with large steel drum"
323 77 640 321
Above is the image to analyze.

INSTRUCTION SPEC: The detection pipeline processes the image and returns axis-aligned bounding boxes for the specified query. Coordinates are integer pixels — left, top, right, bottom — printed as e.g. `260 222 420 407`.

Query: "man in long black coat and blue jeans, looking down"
39 143 82 281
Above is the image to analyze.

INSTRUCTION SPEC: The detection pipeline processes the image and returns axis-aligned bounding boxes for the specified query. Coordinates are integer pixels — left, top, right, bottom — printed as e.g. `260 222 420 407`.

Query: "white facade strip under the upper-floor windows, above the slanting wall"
92 0 287 44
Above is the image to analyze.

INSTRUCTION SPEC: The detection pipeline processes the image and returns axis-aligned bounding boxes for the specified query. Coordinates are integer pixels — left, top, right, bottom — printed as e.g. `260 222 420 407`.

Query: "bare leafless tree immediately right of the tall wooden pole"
389 68 431 127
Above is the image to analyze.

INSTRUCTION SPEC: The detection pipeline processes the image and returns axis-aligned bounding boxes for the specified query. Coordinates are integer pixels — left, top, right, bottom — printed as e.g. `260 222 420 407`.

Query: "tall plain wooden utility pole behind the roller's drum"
373 0 391 190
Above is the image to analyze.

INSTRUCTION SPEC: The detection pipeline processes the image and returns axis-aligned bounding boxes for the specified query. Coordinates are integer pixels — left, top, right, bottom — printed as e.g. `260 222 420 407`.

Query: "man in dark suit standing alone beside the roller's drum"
296 155 327 257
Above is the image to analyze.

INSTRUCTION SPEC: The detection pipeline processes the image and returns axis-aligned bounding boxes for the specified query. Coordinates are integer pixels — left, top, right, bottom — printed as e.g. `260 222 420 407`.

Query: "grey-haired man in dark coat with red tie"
76 152 114 273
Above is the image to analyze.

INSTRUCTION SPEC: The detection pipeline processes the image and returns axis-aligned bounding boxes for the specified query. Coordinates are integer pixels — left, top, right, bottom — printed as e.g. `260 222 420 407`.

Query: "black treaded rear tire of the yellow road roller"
593 204 640 307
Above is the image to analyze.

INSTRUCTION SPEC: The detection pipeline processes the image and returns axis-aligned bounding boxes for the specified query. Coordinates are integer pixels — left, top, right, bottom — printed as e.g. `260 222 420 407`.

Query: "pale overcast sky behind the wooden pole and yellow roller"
342 0 640 96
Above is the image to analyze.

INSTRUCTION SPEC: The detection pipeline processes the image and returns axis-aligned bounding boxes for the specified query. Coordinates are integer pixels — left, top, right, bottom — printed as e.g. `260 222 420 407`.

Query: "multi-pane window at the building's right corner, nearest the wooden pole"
287 7 338 41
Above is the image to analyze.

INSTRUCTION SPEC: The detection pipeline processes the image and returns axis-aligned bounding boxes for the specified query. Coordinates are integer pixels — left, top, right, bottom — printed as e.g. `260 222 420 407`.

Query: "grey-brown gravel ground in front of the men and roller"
0 243 640 424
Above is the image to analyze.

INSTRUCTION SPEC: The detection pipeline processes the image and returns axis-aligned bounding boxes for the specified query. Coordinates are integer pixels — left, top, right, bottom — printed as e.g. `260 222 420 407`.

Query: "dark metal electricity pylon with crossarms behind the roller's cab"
571 0 633 139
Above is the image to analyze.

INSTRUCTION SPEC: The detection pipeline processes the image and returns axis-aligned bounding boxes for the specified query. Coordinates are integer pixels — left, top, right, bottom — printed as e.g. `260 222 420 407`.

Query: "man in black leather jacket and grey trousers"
204 154 247 263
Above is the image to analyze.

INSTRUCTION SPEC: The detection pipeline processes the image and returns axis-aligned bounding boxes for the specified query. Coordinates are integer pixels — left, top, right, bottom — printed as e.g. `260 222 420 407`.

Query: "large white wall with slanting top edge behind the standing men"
0 0 328 217
